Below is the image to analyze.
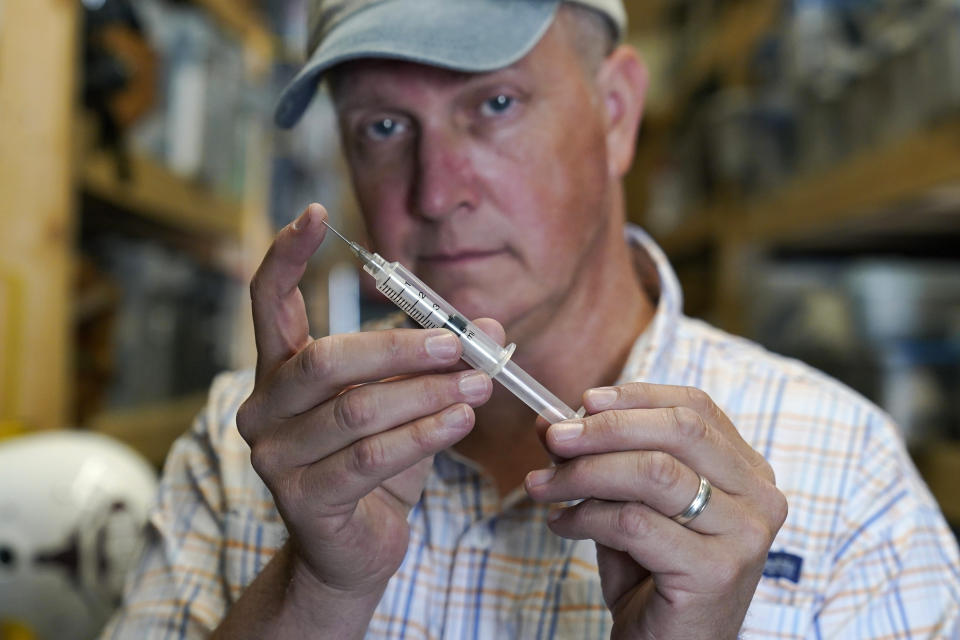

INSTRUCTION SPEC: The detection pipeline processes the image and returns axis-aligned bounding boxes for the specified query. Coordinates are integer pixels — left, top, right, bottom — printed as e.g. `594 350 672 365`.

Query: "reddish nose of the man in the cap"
413 128 478 220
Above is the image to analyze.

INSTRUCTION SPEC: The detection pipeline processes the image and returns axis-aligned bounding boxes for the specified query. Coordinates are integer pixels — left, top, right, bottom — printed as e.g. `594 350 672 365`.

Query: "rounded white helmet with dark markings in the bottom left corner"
0 431 157 640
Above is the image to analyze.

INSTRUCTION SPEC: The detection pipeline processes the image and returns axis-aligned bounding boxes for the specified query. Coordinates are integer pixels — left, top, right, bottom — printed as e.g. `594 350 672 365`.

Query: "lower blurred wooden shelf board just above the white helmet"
85 392 207 468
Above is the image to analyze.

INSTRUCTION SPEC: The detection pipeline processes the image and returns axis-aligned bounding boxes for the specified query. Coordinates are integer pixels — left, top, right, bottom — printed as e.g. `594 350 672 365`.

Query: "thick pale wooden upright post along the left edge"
0 0 79 428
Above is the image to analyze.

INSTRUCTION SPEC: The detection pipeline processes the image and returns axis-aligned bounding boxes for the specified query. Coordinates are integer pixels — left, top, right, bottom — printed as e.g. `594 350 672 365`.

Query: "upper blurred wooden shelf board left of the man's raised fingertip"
80 147 243 239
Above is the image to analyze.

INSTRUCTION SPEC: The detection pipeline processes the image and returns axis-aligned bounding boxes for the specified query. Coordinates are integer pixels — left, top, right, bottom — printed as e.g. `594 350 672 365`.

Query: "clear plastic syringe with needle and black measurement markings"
323 220 582 424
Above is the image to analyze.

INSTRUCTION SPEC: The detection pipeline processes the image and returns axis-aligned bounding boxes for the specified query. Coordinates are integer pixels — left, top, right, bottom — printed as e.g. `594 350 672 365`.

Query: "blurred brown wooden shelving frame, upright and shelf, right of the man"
627 0 960 332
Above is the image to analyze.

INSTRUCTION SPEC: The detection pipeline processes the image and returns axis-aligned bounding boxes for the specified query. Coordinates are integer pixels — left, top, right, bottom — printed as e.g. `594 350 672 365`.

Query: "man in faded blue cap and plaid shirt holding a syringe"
104 0 960 638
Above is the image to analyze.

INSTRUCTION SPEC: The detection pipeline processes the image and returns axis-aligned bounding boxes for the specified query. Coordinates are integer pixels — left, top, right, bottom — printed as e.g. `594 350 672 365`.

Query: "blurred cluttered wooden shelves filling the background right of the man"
627 0 960 531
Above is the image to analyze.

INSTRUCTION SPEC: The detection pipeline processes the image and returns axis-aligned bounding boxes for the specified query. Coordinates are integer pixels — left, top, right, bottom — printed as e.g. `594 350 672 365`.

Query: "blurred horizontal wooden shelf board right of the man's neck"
659 118 960 255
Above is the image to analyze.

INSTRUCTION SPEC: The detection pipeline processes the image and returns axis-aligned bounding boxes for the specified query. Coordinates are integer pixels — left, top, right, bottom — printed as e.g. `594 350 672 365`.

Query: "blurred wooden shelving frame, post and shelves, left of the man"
0 0 279 464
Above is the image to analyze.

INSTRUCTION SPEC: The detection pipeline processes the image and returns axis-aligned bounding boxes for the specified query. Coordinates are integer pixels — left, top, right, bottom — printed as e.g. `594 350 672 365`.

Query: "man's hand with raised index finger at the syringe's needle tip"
237 204 503 600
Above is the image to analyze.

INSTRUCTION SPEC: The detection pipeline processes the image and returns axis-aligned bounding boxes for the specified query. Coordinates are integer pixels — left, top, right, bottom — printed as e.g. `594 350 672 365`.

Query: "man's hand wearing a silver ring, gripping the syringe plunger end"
526 383 787 640
